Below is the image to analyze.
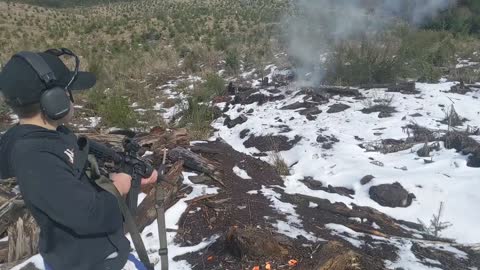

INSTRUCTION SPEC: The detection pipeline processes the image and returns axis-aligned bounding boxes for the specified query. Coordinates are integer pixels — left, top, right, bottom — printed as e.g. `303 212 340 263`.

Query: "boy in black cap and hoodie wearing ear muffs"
0 49 156 270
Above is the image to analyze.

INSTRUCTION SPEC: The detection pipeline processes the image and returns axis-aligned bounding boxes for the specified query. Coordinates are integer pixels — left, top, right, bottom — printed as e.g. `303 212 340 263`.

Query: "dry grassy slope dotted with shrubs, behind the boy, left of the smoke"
0 0 287 129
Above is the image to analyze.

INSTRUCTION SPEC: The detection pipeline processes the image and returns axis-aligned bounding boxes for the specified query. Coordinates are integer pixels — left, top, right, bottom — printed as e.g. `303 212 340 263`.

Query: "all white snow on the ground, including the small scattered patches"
6 65 480 270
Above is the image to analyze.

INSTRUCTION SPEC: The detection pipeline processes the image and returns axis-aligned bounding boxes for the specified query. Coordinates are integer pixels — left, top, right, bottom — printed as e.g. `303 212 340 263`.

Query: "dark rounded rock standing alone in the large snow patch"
369 182 415 208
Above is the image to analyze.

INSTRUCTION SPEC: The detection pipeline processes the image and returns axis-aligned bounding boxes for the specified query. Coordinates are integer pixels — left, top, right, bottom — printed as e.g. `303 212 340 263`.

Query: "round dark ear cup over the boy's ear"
40 87 70 120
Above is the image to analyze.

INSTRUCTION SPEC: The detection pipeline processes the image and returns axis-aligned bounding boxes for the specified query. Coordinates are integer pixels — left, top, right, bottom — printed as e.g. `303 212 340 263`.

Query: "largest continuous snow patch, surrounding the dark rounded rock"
212 81 480 244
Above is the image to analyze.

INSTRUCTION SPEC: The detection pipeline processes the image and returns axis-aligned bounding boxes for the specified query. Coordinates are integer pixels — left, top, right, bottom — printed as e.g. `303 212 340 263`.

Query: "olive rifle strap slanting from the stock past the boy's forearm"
87 155 154 270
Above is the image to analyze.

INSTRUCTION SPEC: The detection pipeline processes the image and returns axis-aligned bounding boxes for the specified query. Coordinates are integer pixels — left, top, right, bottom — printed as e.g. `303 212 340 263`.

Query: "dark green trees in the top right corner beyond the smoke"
427 0 480 34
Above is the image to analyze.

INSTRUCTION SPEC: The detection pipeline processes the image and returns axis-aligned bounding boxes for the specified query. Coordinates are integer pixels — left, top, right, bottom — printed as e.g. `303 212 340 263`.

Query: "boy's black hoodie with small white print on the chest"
0 125 130 270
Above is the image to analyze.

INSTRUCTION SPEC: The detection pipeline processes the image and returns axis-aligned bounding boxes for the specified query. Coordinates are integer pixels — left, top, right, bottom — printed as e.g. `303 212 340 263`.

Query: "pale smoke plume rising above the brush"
282 0 456 83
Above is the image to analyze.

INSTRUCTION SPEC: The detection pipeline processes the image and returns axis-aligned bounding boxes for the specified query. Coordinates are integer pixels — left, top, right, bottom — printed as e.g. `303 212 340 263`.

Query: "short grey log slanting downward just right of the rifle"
168 147 225 186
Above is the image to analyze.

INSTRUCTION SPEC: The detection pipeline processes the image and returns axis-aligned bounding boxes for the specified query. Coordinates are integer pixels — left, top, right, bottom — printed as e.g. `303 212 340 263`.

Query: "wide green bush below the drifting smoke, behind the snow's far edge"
324 27 458 85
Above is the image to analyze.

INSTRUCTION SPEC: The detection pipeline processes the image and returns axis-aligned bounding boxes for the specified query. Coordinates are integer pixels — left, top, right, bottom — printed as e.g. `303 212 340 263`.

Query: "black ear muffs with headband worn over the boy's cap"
16 48 80 120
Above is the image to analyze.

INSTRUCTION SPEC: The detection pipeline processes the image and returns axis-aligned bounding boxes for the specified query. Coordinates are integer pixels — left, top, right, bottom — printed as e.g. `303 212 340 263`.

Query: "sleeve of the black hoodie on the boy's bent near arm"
12 140 123 235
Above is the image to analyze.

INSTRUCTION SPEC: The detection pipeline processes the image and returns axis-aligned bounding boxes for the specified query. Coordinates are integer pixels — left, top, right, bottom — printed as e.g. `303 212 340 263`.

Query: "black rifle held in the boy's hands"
81 137 154 216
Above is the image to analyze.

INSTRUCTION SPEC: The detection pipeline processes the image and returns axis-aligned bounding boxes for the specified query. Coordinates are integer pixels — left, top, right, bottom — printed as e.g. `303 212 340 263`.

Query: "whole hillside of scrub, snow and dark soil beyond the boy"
0 0 480 270
